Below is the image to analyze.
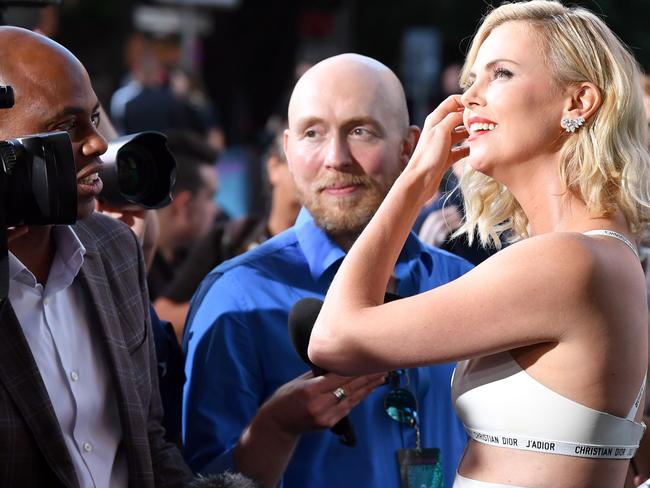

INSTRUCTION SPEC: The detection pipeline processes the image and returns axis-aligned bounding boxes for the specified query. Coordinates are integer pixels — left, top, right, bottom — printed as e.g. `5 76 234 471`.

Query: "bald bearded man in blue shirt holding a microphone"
183 54 470 488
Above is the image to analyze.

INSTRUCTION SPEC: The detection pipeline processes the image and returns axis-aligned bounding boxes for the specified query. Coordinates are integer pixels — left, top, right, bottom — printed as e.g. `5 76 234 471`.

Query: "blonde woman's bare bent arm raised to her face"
309 97 594 374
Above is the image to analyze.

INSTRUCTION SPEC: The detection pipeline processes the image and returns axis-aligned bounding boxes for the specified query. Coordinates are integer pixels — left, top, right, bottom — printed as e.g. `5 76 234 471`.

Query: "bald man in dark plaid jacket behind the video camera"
0 27 191 488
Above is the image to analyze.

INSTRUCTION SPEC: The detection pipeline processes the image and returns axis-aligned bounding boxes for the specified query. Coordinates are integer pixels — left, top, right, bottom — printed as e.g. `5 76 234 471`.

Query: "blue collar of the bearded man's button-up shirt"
294 207 433 280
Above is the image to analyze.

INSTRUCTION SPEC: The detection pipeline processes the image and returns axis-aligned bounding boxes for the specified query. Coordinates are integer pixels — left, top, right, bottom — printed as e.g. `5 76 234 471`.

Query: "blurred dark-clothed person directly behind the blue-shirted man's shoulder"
154 124 300 342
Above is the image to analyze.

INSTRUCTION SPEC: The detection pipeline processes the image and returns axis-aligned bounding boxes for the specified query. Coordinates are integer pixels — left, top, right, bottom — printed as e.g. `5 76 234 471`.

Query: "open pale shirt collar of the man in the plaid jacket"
9 225 86 286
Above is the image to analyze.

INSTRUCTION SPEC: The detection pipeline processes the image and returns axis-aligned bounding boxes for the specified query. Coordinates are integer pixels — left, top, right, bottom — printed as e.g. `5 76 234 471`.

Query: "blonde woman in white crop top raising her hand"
309 1 650 488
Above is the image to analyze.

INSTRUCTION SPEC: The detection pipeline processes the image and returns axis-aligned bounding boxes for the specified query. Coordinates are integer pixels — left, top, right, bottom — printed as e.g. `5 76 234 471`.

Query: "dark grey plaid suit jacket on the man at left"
0 214 191 488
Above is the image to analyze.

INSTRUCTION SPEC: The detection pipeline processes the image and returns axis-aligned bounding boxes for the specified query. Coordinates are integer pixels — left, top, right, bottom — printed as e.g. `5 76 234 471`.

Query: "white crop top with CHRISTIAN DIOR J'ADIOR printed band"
452 231 646 459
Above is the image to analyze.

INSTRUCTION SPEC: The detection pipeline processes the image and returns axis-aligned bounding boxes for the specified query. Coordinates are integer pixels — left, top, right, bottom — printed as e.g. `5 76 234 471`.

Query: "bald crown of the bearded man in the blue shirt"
289 53 409 134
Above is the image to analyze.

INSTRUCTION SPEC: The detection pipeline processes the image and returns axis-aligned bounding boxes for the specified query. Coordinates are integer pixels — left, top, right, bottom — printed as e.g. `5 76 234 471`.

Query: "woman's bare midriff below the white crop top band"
458 441 629 488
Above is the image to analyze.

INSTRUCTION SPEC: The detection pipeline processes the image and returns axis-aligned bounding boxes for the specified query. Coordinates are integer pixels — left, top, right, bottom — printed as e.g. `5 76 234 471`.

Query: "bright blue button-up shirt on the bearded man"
183 210 471 488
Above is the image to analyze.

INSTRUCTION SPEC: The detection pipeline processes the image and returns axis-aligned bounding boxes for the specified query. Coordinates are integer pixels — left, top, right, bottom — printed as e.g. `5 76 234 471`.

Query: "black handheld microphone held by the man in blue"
289 298 357 447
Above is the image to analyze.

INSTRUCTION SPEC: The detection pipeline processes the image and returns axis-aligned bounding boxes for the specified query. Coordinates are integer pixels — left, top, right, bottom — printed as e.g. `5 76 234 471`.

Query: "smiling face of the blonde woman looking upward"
461 22 567 182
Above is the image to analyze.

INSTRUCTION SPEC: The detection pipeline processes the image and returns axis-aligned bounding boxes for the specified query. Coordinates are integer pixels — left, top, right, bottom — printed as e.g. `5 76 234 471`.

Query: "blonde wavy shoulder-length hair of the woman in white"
457 0 650 244
